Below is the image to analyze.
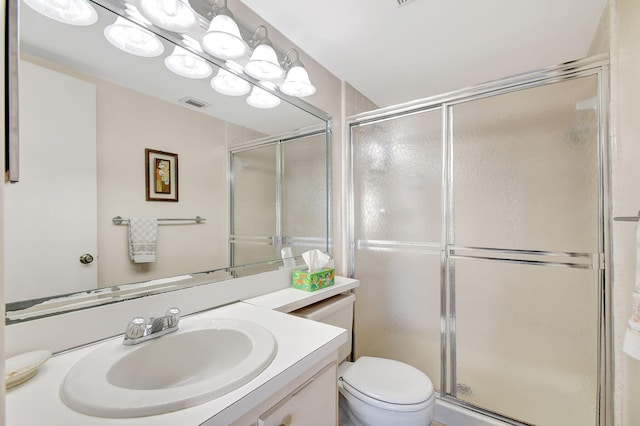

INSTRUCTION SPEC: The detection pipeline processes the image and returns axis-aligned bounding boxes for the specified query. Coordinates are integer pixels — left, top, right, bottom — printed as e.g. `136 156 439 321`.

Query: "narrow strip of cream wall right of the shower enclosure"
611 0 640 426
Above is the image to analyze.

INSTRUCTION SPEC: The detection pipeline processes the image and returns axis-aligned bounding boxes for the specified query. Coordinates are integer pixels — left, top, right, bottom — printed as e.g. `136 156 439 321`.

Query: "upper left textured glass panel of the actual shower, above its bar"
352 109 442 243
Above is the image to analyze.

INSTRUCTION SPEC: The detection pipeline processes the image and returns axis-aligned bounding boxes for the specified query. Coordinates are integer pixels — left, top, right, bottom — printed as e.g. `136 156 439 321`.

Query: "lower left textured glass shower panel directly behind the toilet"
354 250 440 389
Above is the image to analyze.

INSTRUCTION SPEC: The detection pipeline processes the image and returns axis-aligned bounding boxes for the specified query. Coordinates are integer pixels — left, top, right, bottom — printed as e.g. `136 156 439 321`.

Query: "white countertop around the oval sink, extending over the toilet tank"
6 302 348 426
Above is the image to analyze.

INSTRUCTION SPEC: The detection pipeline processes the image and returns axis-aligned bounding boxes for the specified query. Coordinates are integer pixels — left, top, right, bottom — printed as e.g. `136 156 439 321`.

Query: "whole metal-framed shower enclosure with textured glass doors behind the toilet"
349 58 610 426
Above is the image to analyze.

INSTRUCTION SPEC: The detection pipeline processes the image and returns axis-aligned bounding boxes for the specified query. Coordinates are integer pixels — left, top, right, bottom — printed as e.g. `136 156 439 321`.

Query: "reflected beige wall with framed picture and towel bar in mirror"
97 78 229 286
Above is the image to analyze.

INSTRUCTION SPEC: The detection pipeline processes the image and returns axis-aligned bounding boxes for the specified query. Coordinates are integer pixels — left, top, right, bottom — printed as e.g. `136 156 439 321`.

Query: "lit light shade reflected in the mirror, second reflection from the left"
104 16 164 58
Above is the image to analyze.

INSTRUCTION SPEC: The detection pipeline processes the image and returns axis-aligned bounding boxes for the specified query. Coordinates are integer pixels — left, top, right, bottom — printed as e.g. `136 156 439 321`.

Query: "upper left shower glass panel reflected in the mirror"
232 145 276 236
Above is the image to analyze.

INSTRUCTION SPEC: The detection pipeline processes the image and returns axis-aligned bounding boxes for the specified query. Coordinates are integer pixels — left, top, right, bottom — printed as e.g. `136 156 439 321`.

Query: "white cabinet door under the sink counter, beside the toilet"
258 364 338 426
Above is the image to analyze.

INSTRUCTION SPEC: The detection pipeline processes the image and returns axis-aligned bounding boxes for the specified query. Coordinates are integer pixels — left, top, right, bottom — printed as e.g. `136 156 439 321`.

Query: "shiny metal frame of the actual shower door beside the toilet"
347 55 613 426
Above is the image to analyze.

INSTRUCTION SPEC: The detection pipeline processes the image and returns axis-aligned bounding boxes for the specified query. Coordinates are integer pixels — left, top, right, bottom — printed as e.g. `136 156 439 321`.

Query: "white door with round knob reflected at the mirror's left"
4 61 98 302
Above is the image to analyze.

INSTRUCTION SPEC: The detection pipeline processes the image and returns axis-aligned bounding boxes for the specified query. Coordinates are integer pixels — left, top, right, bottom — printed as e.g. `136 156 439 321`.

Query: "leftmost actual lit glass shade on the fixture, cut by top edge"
139 0 198 33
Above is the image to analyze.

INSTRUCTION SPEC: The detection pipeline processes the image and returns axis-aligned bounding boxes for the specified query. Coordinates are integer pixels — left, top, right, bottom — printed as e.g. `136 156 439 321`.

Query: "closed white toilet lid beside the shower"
342 356 433 404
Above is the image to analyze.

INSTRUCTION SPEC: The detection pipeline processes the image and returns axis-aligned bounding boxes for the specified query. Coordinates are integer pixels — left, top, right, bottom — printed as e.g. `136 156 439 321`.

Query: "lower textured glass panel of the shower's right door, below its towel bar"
455 259 598 426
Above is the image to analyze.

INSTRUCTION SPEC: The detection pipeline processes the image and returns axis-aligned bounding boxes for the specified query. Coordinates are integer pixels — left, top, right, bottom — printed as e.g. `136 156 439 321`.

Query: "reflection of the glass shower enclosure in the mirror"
229 129 330 276
